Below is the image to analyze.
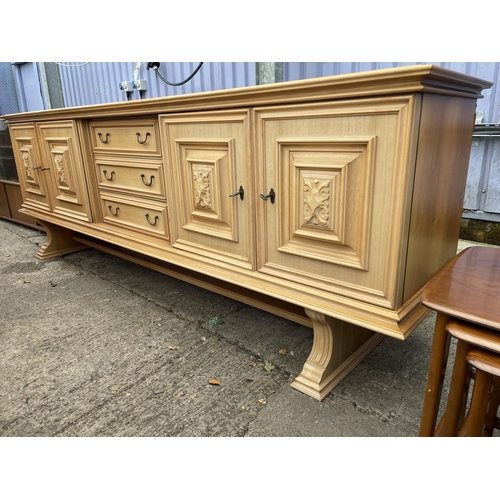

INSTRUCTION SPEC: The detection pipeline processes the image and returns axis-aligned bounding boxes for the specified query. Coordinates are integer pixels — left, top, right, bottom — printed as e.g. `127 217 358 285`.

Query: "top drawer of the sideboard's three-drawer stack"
90 118 160 155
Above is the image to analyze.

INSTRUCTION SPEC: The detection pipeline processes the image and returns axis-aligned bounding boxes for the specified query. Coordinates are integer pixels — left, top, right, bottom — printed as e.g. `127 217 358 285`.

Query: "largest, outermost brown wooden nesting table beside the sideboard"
419 247 500 436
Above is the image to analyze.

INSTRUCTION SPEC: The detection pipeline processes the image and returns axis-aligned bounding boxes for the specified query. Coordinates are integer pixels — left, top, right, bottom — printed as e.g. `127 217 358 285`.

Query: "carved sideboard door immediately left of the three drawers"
37 121 90 221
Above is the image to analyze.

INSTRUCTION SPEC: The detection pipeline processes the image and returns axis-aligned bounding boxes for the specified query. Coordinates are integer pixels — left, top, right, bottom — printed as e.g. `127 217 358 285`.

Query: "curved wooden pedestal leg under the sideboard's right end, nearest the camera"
291 309 384 401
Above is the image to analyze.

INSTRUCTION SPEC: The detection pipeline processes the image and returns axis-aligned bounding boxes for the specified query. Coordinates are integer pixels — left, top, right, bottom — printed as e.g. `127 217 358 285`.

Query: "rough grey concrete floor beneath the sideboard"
0 220 498 437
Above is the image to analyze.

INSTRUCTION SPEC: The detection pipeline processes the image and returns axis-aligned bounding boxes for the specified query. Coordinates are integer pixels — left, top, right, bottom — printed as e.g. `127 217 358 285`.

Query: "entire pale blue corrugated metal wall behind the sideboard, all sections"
4 61 500 214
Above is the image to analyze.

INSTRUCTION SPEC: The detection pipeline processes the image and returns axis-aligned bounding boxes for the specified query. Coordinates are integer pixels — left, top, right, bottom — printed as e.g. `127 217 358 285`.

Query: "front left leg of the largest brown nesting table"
419 313 450 437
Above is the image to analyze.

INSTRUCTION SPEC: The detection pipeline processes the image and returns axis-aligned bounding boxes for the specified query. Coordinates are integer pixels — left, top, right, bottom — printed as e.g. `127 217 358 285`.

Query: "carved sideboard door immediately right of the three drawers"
160 110 254 269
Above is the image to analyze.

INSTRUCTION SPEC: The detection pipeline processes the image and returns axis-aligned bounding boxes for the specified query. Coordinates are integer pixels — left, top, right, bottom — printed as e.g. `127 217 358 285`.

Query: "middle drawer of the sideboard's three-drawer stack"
95 157 165 200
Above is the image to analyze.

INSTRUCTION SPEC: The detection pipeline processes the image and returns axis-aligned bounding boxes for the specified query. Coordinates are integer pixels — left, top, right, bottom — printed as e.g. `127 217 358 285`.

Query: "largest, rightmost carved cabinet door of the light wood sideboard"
256 96 419 308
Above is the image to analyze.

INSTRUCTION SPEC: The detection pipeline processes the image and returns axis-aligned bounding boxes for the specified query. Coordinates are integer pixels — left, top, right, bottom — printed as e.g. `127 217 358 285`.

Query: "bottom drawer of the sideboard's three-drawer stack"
101 193 169 240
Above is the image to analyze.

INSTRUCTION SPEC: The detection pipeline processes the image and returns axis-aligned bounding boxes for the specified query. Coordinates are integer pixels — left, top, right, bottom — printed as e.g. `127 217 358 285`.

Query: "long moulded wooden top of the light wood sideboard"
2 64 493 123
